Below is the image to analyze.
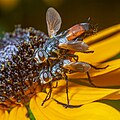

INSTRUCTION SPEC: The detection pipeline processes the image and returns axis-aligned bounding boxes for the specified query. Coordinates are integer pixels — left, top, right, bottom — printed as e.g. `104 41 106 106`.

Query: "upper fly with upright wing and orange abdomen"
34 7 96 63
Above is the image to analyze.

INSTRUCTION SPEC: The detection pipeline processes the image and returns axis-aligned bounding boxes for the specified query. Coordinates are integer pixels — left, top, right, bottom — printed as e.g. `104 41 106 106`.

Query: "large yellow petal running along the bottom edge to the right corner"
30 93 119 120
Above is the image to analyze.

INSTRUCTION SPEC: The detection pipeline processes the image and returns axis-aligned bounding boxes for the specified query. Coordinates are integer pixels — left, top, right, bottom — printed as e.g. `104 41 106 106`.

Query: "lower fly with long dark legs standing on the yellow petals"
40 59 108 107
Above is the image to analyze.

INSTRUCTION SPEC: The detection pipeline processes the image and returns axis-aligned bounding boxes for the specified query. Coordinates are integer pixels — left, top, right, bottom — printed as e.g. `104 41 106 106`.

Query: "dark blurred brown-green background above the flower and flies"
0 0 120 34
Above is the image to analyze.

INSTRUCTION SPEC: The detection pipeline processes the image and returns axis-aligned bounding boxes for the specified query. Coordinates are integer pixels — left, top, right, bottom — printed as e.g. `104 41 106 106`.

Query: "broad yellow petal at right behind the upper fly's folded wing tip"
76 33 120 64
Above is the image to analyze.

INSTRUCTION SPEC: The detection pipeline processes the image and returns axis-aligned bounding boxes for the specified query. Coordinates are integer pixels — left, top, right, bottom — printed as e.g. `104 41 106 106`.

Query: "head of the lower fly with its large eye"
39 70 52 84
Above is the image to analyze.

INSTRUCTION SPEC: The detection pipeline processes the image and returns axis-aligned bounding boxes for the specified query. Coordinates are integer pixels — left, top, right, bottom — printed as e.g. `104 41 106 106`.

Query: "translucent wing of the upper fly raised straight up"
46 7 62 37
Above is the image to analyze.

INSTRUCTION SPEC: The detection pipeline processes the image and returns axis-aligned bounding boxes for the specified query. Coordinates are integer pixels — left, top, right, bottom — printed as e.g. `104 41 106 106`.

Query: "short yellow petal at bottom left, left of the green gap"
9 106 29 120
